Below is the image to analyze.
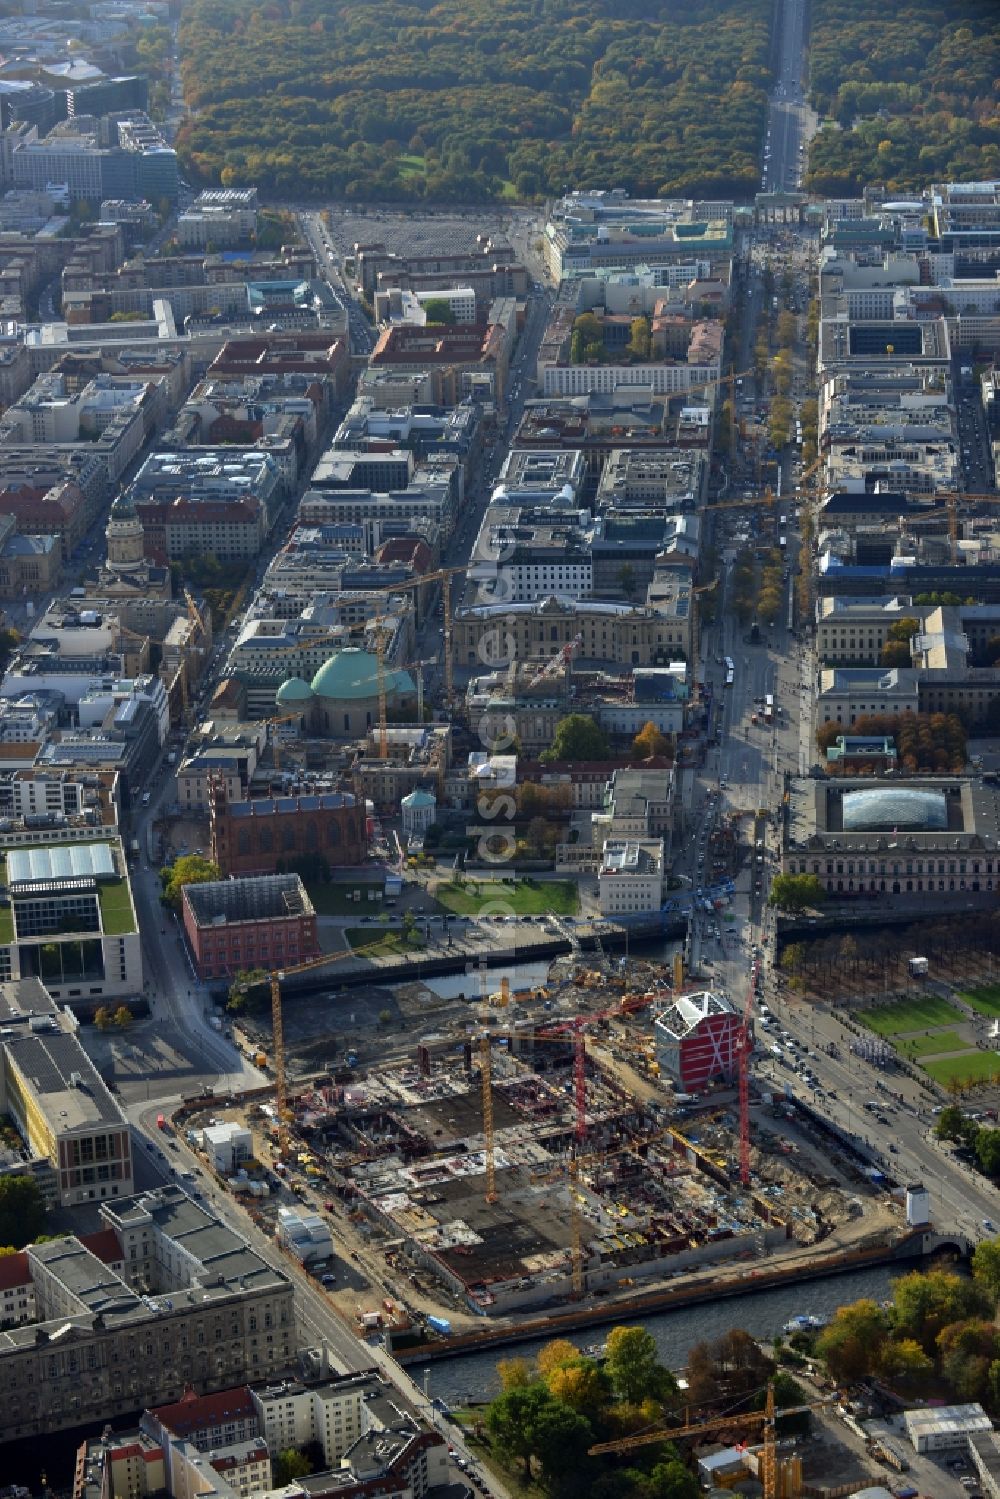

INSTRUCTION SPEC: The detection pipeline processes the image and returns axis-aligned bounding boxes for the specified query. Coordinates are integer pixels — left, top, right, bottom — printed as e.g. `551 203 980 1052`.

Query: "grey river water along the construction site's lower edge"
419 1264 915 1405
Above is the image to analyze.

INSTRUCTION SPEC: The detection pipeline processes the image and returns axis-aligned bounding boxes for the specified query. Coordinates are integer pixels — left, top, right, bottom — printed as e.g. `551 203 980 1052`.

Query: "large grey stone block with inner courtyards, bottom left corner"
0 1186 295 1441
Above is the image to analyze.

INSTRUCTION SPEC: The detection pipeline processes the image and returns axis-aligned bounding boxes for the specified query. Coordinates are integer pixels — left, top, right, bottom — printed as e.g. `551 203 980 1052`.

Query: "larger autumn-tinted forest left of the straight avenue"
177 0 772 202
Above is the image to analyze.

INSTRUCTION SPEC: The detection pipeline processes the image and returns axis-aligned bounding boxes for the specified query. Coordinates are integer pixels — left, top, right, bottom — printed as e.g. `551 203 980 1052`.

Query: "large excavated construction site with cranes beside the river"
215 959 900 1325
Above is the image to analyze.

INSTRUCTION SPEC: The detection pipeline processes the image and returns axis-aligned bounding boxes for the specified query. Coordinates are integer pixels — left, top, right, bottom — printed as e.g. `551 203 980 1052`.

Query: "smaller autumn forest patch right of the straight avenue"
805 0 1000 193
